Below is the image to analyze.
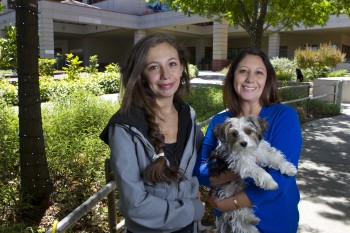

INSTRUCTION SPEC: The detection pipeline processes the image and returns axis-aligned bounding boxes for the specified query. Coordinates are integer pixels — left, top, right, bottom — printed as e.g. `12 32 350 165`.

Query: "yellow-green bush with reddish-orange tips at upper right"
295 43 345 80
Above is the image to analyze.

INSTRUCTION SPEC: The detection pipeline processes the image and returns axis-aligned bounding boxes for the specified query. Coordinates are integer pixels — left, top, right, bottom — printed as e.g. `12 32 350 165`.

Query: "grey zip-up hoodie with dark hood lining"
101 103 205 233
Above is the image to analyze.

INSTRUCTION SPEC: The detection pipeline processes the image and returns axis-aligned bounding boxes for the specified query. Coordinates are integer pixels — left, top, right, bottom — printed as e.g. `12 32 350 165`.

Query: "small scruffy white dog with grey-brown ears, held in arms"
209 116 297 233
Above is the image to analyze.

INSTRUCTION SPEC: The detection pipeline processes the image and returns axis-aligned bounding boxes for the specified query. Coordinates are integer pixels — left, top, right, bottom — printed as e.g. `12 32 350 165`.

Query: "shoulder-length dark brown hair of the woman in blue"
223 49 279 116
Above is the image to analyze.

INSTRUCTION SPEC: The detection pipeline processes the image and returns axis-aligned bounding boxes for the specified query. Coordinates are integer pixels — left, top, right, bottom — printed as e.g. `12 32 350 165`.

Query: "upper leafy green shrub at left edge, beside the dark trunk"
0 25 17 69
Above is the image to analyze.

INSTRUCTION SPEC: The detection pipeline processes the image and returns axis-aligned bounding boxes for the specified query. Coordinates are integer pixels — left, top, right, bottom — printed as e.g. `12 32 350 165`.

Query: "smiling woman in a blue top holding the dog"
195 49 302 233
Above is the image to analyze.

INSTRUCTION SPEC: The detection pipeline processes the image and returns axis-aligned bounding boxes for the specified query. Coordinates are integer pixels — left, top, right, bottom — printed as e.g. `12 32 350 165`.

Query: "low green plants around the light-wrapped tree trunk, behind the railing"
0 92 119 232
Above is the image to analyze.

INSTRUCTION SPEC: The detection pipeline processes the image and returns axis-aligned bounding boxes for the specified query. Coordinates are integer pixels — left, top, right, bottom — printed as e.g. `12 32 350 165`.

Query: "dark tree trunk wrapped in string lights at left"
16 0 52 220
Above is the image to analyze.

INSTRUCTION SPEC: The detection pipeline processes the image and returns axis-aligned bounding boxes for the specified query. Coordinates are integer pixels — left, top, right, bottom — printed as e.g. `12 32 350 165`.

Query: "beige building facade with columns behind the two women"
0 0 350 70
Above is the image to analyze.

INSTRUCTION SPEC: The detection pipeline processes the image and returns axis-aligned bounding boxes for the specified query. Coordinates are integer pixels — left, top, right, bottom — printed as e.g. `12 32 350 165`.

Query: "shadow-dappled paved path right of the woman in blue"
297 112 350 233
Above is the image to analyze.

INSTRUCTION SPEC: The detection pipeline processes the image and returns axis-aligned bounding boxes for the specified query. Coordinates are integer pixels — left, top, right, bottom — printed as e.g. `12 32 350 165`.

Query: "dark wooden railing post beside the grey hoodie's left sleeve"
105 159 117 233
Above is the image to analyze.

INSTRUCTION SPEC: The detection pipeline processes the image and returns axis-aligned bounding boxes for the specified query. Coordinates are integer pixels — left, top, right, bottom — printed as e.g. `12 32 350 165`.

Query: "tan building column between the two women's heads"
212 21 228 71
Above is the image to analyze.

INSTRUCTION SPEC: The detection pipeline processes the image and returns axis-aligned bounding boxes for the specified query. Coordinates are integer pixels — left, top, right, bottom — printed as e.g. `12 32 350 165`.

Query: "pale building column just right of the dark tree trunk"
39 7 55 58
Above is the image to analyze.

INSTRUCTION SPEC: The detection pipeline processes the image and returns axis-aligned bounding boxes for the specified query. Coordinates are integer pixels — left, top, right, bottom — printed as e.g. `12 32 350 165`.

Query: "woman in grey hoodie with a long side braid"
101 34 204 233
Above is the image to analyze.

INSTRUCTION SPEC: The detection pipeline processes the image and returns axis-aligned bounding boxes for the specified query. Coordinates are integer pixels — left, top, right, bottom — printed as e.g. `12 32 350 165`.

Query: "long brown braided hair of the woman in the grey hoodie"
121 33 190 183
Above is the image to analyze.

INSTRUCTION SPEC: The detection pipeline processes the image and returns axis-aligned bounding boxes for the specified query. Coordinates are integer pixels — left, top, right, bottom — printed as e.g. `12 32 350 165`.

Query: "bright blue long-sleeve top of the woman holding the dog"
194 104 302 233
